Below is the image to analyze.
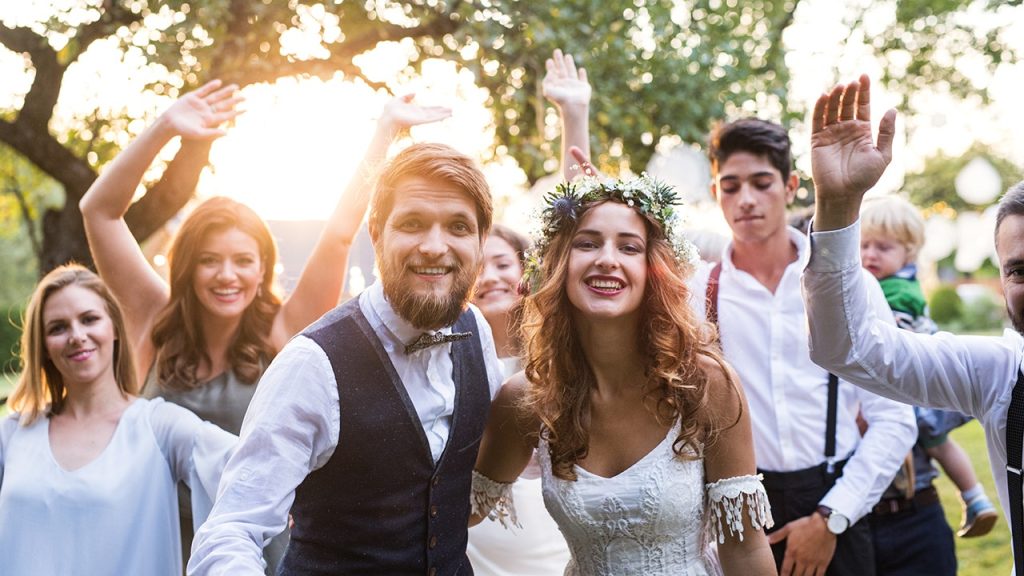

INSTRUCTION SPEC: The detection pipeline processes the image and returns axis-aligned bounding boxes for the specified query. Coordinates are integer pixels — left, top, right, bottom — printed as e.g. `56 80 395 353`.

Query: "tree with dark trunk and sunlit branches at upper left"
0 0 462 272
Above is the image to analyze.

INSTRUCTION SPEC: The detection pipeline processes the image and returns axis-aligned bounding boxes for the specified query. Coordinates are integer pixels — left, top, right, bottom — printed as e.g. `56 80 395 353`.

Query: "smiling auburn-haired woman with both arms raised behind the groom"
81 80 451 572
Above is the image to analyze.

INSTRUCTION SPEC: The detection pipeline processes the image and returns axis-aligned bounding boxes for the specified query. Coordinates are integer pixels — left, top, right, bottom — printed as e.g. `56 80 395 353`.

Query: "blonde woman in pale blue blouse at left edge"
0 264 237 576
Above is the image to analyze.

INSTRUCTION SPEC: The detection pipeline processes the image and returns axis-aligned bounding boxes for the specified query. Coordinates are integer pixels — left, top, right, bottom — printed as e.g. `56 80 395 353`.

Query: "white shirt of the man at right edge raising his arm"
804 221 1024 545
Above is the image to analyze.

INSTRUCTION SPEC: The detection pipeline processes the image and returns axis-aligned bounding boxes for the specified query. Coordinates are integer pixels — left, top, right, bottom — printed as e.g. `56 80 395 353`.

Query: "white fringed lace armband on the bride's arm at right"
705 475 775 544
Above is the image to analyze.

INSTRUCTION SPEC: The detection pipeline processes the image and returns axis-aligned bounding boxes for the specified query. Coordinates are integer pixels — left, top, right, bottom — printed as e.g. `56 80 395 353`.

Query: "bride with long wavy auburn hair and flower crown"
473 176 775 576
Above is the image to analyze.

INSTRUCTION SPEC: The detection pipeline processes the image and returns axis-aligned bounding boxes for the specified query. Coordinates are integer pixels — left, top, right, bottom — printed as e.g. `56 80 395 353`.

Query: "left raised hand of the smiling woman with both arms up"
161 80 245 140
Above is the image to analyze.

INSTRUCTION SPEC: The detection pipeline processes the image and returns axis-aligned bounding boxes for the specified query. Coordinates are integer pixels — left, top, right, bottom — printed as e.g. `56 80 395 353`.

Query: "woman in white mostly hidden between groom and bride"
466 224 569 576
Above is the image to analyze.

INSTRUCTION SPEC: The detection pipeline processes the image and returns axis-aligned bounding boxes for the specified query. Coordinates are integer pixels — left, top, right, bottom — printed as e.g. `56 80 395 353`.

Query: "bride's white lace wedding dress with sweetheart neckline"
538 424 718 576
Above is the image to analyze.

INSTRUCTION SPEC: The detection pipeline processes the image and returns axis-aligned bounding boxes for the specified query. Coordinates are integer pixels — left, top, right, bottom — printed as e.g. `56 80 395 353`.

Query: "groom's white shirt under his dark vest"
188 282 502 576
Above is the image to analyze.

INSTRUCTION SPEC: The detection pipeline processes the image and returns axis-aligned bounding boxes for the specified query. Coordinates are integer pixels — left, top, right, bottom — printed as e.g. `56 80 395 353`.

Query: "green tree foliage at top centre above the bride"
464 0 797 181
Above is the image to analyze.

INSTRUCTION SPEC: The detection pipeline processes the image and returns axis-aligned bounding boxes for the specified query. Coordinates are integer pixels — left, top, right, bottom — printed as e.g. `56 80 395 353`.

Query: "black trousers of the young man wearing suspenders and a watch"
759 461 874 576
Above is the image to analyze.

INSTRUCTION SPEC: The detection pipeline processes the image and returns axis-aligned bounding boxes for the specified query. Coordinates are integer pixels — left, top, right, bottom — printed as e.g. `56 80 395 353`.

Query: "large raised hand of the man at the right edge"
811 75 896 230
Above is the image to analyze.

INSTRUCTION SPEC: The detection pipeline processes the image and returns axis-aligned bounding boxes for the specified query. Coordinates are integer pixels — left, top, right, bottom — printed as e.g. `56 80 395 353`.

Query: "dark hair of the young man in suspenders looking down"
708 118 793 180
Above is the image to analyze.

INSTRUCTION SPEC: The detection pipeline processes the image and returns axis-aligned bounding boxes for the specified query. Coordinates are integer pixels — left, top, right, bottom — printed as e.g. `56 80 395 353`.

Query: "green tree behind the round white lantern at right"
902 143 1024 212
